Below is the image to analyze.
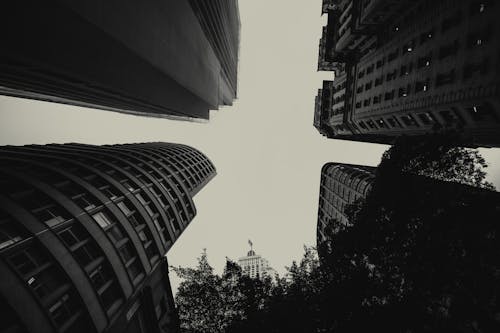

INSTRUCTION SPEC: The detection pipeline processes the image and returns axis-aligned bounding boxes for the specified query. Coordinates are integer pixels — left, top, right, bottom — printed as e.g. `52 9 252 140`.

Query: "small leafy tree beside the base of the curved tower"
172 251 272 333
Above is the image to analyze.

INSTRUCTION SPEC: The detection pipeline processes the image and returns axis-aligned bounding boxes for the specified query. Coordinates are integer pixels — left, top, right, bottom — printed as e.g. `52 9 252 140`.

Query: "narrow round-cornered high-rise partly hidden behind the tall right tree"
316 163 375 244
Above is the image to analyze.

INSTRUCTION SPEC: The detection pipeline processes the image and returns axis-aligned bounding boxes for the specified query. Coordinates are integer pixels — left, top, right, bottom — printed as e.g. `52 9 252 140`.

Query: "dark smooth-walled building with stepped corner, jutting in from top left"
0 0 240 120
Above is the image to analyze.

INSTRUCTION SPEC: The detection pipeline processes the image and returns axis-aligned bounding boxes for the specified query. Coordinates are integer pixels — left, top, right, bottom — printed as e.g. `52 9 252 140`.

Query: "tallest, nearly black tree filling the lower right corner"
316 135 500 332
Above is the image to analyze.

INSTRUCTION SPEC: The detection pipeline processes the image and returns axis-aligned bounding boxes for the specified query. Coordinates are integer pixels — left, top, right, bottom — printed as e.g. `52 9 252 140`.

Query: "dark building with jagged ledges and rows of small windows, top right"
314 0 500 147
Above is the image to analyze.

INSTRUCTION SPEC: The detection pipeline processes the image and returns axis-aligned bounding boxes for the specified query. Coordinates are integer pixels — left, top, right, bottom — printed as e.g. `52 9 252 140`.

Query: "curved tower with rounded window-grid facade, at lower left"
0 143 216 333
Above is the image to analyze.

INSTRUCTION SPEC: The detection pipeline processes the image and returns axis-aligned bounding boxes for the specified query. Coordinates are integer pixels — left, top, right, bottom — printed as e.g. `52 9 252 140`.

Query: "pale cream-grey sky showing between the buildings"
0 0 500 290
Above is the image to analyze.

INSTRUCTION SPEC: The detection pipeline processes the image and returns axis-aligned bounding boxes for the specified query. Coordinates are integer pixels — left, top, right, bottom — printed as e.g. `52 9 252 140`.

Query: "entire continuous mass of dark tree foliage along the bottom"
177 134 500 333
